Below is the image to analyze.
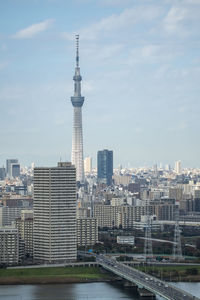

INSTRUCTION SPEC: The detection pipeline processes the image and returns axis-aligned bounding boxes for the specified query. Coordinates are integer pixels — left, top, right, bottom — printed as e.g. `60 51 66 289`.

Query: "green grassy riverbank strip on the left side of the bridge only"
0 267 114 285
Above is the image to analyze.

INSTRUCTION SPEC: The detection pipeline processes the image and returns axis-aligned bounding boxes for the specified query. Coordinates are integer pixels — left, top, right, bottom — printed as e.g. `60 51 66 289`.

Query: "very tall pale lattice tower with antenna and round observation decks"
71 35 84 183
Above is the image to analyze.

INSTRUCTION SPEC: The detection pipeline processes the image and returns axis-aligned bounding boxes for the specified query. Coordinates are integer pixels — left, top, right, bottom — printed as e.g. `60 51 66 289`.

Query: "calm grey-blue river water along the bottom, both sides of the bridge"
0 282 200 300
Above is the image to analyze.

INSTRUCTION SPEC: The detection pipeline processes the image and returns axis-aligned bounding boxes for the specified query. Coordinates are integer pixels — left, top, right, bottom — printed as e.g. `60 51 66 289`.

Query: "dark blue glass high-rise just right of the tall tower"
97 149 113 185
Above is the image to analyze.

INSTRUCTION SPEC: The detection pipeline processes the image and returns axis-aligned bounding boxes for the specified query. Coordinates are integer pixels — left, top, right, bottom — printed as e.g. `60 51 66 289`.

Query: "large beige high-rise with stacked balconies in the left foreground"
33 162 77 263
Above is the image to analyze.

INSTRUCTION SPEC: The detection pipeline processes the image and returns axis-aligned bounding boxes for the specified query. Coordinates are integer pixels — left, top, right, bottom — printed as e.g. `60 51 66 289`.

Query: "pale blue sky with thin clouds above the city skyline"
0 0 200 167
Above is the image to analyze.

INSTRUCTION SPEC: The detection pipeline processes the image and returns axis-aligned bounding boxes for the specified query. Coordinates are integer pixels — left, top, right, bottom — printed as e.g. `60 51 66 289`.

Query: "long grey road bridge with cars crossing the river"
95 255 200 300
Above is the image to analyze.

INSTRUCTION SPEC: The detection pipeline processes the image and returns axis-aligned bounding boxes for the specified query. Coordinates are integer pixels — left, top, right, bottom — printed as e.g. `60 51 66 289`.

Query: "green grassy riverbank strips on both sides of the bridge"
0 266 200 285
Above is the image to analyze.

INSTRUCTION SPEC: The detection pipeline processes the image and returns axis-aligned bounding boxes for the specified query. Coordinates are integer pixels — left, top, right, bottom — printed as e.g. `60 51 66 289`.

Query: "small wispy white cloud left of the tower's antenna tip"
12 19 54 39
